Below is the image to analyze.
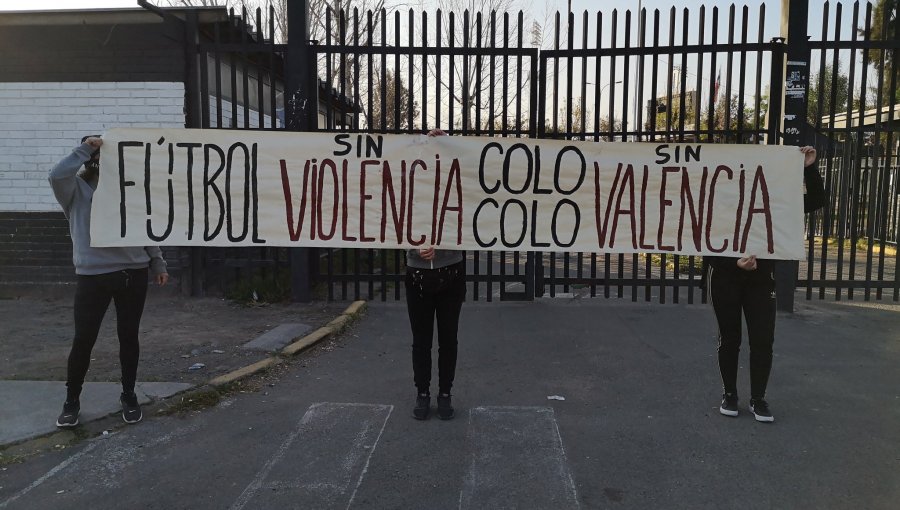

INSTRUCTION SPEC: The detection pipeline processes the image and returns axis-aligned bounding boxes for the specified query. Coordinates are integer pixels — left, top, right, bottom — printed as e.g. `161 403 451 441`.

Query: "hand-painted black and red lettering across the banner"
110 134 774 253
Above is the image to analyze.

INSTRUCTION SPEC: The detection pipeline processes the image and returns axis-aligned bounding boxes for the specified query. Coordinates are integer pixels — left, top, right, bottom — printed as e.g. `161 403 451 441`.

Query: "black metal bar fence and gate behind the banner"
187 3 900 302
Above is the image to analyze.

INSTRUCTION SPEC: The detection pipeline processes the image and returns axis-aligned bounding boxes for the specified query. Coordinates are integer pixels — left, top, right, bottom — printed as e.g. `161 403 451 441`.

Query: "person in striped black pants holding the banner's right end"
705 146 818 422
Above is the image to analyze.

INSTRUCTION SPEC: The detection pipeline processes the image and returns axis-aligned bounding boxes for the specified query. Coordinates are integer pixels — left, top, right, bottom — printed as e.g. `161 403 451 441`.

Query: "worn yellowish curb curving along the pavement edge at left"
0 301 368 458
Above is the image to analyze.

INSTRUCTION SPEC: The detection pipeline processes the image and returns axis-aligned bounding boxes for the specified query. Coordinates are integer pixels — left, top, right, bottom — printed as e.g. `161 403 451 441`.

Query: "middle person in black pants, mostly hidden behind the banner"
406 129 466 420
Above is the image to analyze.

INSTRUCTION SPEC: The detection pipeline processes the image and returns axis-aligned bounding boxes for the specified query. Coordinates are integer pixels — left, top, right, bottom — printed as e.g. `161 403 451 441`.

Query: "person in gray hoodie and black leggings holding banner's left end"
49 136 169 427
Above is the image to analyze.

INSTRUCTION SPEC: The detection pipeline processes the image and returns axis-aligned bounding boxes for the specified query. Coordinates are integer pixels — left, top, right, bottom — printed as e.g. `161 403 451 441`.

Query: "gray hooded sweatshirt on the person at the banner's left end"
50 143 166 275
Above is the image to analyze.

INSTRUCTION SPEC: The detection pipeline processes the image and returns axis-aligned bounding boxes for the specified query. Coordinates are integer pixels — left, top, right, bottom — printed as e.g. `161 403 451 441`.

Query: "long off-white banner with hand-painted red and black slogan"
91 128 805 260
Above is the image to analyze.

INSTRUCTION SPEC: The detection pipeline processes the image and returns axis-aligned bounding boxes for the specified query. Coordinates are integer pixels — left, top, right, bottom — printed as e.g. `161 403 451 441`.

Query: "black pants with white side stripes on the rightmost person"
707 268 775 398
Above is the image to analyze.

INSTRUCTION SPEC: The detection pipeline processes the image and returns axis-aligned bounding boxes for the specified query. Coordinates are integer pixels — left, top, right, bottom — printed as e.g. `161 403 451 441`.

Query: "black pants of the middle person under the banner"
406 261 466 394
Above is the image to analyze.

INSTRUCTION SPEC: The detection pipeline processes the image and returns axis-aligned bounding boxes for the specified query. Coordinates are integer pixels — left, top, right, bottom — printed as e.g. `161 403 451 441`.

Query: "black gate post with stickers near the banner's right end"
770 0 810 312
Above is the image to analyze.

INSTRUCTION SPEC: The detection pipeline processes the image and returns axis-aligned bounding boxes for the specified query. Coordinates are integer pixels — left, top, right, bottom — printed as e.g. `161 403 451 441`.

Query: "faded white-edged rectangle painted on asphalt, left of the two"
231 402 394 510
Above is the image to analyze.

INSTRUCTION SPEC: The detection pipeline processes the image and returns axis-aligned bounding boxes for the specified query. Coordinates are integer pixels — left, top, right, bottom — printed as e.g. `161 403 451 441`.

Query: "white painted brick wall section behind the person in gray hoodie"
0 82 184 211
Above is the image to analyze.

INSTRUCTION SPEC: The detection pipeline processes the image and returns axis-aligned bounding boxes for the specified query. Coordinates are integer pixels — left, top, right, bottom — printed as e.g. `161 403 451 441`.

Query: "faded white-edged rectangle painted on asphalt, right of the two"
459 407 580 510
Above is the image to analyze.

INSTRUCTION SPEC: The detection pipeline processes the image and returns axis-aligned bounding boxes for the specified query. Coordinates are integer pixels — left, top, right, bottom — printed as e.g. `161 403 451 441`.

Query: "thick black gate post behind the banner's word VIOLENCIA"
284 0 319 302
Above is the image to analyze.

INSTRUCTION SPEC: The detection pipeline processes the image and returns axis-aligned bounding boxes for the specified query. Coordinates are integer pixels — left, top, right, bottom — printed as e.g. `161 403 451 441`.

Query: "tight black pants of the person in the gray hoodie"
66 268 148 401
